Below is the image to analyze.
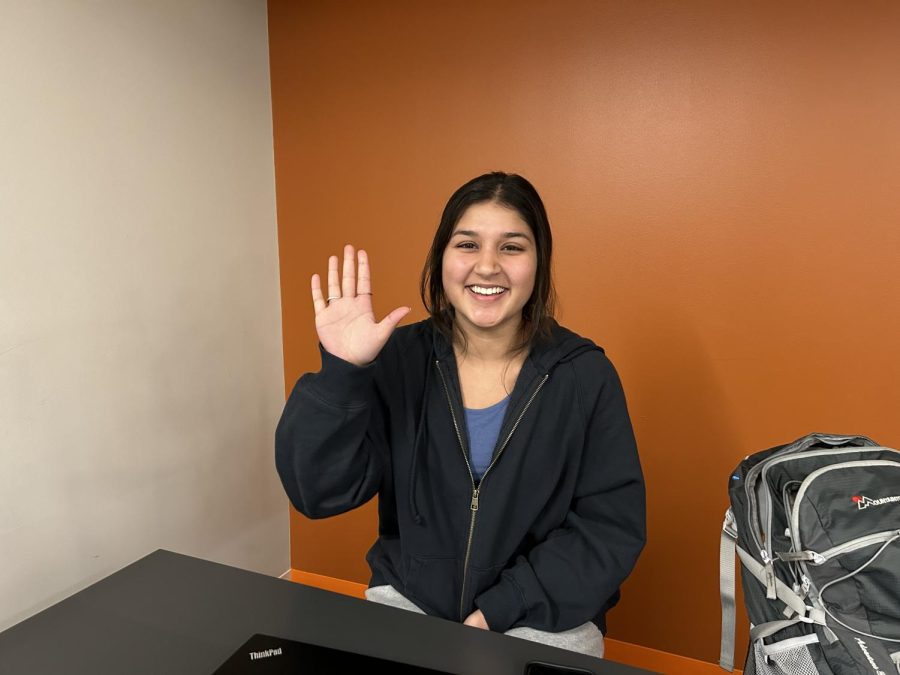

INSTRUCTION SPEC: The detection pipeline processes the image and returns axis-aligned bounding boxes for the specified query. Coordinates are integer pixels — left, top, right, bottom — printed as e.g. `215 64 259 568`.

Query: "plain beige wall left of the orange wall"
0 0 288 629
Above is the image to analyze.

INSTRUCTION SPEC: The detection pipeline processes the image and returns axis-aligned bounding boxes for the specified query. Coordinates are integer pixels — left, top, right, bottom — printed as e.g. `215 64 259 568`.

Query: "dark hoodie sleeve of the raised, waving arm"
275 345 390 518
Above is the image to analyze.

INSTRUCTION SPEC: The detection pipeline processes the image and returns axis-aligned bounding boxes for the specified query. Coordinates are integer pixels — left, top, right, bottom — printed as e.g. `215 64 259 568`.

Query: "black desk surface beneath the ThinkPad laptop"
0 550 649 675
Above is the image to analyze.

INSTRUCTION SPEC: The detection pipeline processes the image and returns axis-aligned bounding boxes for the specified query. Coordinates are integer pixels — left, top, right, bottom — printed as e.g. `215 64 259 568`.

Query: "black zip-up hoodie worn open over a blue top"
275 320 645 632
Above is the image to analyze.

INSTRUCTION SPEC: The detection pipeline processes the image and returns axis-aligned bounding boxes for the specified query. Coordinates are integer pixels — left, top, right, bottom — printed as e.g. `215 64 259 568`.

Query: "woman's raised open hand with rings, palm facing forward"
312 244 410 366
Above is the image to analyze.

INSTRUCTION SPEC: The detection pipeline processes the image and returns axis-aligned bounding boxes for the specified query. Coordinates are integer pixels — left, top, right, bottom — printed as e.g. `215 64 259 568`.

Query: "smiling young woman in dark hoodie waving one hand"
276 173 645 656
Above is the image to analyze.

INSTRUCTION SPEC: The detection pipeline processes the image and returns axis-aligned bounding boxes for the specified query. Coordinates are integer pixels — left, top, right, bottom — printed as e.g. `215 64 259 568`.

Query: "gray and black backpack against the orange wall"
719 434 900 675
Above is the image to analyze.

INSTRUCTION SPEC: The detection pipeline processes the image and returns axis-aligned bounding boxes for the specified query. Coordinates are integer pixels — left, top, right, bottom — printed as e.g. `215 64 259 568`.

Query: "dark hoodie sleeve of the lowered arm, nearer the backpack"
475 352 646 632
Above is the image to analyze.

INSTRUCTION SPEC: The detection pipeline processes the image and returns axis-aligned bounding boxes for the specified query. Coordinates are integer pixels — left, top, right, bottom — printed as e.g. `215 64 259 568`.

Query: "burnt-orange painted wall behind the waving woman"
269 0 900 661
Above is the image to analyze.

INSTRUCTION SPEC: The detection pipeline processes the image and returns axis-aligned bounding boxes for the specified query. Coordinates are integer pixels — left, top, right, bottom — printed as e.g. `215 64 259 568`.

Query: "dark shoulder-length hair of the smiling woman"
419 171 556 352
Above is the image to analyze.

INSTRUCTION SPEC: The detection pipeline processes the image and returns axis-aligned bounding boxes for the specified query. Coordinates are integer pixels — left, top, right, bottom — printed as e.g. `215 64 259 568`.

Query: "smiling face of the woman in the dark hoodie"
442 202 537 334
